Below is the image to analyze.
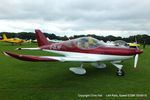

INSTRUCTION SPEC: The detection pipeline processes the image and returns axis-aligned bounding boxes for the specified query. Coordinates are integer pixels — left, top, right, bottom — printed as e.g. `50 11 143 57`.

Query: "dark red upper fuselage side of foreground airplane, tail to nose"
40 41 142 56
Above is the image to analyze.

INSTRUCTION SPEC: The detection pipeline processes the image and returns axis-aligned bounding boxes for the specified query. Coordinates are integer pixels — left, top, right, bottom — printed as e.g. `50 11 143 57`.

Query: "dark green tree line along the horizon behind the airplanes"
0 32 150 44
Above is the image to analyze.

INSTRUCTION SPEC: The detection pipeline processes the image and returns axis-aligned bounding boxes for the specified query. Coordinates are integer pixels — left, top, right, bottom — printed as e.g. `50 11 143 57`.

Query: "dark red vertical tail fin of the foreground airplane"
35 29 51 47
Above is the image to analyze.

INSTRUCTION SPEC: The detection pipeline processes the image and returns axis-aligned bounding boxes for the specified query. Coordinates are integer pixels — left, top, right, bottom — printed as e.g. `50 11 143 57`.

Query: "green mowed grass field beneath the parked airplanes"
0 42 150 100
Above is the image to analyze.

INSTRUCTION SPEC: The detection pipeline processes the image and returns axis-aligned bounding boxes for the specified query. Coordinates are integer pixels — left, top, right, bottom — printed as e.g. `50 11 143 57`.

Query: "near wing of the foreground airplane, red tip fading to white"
4 52 98 62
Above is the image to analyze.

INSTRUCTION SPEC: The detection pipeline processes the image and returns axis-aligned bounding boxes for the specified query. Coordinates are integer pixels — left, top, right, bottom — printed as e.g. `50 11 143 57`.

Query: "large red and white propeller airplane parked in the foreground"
4 30 143 76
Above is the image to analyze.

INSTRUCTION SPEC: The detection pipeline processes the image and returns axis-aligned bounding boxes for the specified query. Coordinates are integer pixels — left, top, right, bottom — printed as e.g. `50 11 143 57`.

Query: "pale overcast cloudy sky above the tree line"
0 0 150 37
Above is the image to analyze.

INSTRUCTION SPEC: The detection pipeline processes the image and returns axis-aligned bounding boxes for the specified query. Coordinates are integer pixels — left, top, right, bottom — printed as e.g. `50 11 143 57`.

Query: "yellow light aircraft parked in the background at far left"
0 34 24 45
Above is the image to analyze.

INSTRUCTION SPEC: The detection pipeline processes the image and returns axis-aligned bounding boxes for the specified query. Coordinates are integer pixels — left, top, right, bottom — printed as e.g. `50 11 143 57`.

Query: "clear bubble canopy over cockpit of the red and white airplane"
74 37 105 49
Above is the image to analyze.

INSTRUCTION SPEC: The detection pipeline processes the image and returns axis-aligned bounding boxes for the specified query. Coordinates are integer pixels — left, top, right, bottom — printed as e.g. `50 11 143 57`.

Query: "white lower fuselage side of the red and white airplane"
43 49 134 61
